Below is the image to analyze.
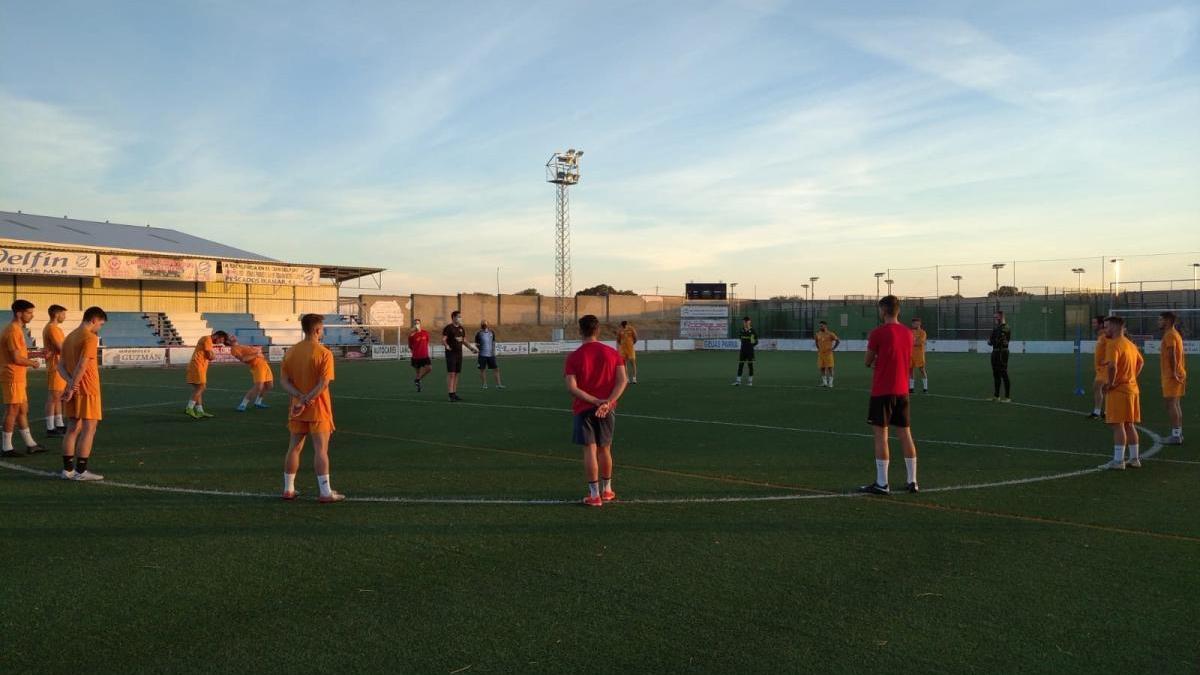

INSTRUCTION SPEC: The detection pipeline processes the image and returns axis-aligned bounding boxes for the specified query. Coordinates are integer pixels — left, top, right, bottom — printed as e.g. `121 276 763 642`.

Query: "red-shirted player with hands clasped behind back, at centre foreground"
563 315 629 506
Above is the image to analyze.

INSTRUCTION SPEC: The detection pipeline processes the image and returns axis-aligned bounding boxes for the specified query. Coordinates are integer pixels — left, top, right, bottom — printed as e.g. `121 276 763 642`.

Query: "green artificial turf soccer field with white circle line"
0 352 1200 673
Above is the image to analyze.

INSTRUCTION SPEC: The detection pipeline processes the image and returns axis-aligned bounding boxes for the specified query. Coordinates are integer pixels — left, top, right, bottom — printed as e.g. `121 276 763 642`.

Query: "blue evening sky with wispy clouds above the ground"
0 0 1200 295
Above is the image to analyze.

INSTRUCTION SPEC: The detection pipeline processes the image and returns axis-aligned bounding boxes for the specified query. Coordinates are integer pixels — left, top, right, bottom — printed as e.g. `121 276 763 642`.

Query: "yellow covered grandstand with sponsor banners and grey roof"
0 211 384 348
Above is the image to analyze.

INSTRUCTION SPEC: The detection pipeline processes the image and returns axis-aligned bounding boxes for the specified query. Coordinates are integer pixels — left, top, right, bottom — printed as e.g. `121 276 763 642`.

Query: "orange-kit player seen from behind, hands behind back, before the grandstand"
280 313 346 504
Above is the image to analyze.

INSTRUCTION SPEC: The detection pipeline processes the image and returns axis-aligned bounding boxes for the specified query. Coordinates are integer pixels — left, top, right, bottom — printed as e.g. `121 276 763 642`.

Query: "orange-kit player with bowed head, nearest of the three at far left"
58 307 108 480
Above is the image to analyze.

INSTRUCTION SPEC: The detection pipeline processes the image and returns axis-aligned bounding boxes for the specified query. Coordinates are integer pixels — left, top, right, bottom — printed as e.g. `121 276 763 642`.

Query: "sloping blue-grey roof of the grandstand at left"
0 211 277 262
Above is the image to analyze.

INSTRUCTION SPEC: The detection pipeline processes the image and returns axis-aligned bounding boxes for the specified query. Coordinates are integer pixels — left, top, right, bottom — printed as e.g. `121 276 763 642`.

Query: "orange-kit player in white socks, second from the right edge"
1103 316 1146 470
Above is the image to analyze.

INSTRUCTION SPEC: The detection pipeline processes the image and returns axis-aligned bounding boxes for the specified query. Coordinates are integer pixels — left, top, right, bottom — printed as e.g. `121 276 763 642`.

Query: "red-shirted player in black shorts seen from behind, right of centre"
858 295 920 495
